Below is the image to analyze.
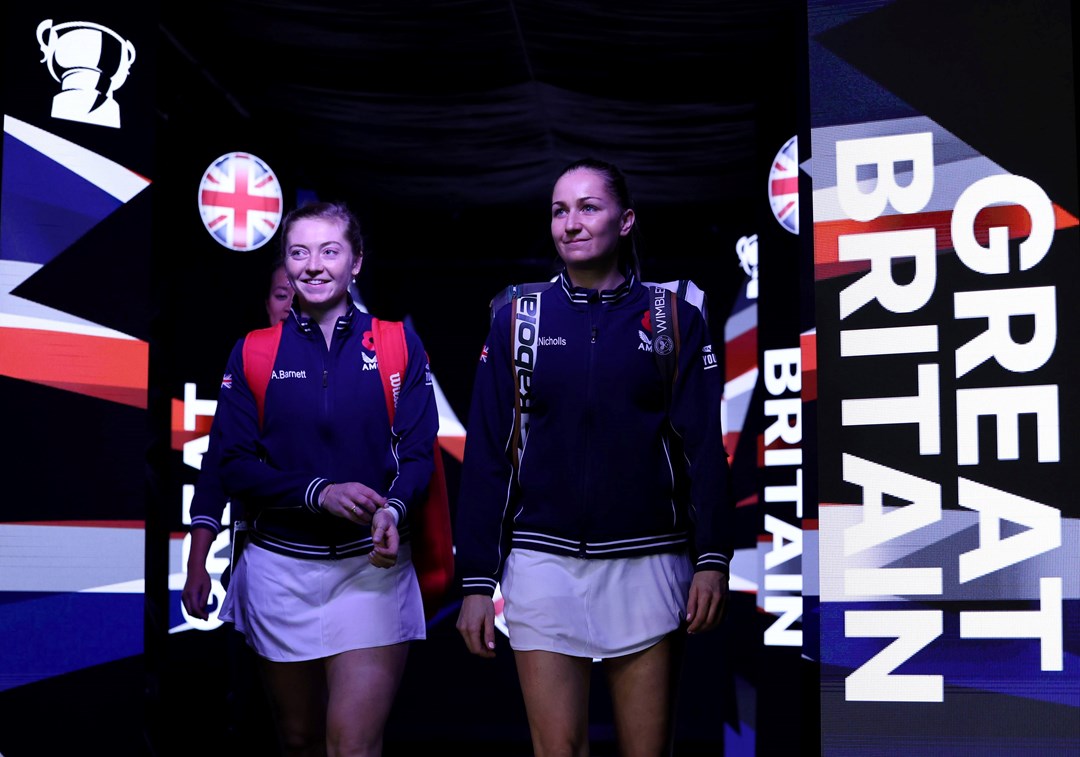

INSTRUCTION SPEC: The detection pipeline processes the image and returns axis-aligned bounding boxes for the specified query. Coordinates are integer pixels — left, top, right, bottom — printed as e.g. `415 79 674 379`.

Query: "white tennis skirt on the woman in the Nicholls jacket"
501 549 693 659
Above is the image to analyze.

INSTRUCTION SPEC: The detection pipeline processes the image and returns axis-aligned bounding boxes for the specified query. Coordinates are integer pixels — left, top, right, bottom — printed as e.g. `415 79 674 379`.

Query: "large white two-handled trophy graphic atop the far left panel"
38 18 135 129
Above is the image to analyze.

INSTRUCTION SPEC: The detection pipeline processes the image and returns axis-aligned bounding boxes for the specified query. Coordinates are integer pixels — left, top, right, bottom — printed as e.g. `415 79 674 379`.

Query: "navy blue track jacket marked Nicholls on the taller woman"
455 272 733 596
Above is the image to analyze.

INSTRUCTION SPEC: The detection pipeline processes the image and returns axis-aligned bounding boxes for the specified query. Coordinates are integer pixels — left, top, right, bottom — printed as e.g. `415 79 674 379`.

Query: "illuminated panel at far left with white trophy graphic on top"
0 2 156 708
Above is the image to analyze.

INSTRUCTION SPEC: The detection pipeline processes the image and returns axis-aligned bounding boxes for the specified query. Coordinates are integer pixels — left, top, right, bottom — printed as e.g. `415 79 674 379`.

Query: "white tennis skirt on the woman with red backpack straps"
218 543 427 662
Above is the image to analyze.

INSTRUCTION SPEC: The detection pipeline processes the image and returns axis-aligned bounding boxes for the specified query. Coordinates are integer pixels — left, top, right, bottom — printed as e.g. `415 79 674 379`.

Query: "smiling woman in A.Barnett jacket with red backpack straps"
195 197 438 755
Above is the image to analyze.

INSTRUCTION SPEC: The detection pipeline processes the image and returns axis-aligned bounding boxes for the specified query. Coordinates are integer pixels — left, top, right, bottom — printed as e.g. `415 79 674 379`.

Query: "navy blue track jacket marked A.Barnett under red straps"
212 303 438 558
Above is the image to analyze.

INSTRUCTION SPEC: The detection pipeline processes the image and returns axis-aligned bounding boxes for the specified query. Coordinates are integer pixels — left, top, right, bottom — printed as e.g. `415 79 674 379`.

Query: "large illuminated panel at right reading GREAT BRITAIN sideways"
808 0 1080 755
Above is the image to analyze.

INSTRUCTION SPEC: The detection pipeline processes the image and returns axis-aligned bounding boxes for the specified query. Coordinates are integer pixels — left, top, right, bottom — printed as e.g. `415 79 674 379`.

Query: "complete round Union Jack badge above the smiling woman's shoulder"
199 152 283 252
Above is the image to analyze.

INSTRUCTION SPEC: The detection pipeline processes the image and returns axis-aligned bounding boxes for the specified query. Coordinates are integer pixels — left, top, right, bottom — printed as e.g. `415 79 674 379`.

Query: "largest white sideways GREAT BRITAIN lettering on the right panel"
829 133 1064 702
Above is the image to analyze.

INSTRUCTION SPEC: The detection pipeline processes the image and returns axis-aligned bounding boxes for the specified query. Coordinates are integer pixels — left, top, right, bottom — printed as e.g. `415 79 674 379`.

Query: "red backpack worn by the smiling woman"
243 319 454 620
